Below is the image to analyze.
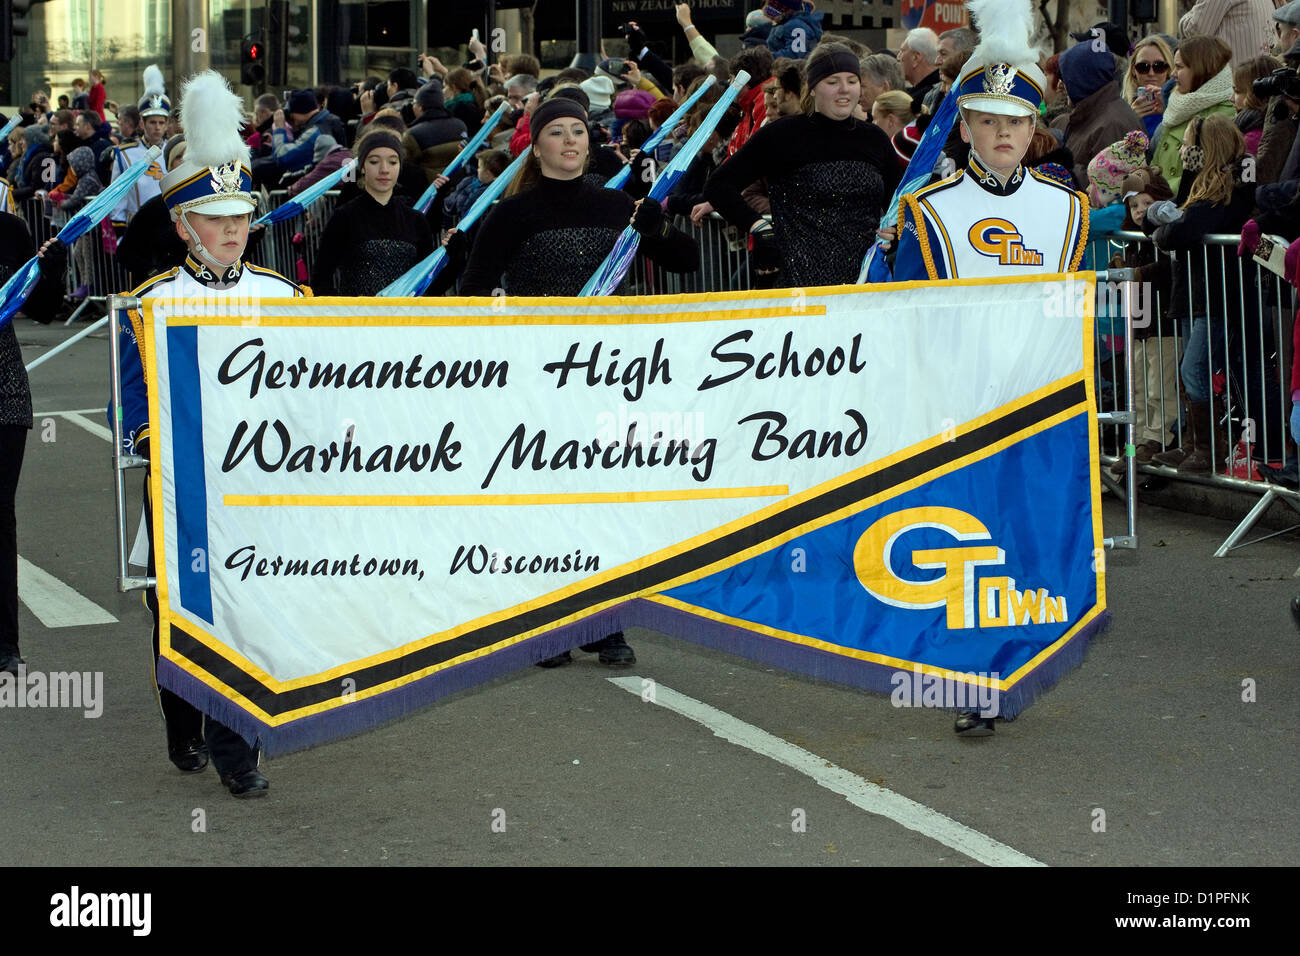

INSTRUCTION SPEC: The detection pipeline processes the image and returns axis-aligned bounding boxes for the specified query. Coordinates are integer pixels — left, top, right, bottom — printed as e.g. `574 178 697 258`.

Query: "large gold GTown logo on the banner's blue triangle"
853 507 1069 631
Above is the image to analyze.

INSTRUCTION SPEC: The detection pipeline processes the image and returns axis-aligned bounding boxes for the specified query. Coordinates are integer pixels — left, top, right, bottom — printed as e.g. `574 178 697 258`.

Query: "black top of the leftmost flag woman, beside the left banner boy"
312 191 433 295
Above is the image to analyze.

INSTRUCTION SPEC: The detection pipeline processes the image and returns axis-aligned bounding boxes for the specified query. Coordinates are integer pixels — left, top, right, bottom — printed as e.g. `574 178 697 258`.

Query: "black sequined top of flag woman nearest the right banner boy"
705 113 901 286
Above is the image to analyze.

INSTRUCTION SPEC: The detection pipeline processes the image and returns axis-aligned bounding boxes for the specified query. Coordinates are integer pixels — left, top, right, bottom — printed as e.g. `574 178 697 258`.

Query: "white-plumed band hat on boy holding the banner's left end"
160 70 257 219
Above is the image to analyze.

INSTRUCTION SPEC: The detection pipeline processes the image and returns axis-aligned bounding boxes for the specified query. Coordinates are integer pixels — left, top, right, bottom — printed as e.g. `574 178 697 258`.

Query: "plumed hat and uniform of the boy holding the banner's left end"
109 72 304 796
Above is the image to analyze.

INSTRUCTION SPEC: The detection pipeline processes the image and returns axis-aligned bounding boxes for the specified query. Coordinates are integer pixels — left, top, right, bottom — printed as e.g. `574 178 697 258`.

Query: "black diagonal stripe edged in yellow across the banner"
172 380 1087 715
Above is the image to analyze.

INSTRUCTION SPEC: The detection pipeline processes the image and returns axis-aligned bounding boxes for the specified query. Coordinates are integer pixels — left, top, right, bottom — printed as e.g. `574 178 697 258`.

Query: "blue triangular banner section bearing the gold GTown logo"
664 414 1097 680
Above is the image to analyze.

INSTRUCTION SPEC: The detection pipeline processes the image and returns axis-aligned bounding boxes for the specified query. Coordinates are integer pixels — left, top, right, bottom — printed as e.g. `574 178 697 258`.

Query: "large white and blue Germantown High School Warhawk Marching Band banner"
131 273 1106 754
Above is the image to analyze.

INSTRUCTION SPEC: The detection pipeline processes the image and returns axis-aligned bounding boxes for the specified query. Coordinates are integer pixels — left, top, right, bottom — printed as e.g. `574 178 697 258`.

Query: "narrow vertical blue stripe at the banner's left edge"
166 325 212 624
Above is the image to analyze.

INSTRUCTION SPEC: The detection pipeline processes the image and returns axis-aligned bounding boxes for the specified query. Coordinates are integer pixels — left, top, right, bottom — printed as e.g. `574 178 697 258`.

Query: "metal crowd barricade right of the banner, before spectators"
1096 233 1300 558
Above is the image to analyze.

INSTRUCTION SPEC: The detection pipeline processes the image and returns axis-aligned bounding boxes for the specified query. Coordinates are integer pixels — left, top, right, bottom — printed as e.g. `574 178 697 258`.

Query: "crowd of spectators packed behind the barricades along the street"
0 0 1300 468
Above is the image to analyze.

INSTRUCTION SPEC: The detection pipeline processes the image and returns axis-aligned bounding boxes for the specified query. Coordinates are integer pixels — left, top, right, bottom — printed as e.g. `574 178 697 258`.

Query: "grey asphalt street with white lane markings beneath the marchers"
0 320 1300 866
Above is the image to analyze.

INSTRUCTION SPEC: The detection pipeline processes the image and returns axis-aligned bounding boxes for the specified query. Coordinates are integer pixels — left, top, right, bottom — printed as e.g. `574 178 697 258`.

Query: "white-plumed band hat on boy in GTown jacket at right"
953 0 1048 116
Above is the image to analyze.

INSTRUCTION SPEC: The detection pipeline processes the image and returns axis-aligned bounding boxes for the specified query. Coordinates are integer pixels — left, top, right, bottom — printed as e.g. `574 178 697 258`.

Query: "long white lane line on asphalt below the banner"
607 678 1047 866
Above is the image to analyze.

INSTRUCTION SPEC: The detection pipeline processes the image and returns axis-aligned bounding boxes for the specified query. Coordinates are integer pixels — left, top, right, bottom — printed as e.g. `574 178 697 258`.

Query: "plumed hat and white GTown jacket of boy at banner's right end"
893 10 1088 281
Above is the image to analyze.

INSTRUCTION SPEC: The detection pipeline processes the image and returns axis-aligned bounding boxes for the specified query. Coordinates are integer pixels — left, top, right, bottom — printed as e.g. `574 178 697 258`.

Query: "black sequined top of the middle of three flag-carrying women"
460 177 699 295
